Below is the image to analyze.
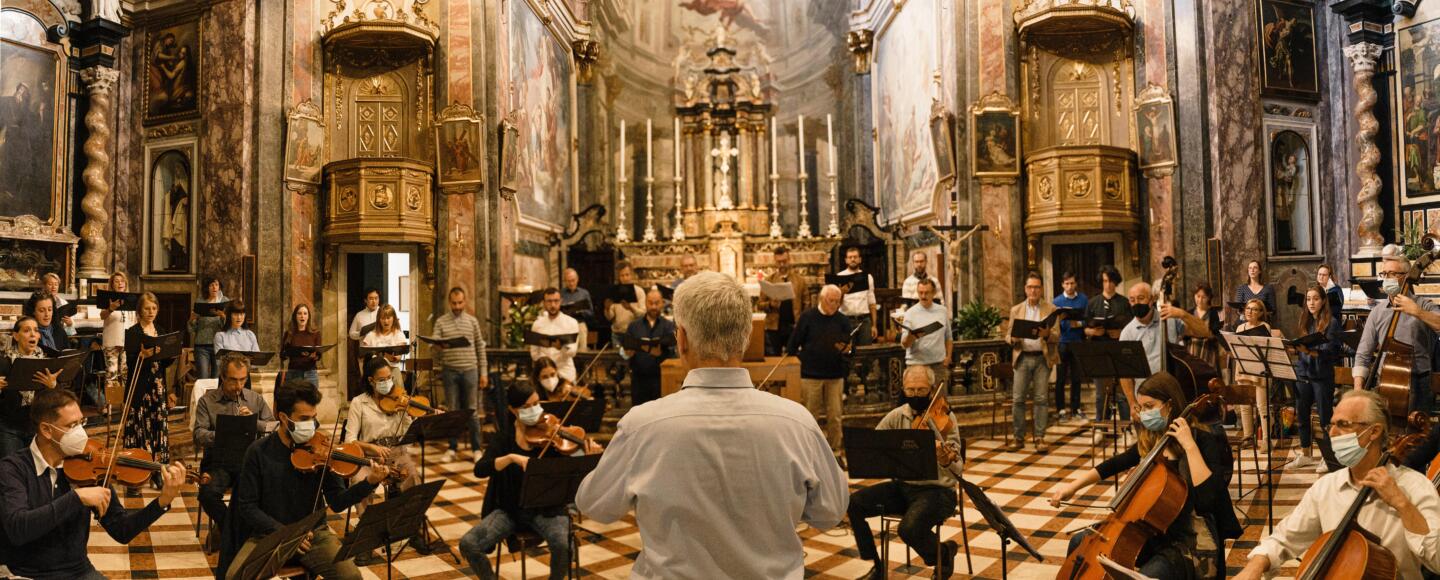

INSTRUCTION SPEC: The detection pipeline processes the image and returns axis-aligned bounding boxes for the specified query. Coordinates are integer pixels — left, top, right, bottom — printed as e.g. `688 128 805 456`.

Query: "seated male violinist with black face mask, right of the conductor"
848 366 960 579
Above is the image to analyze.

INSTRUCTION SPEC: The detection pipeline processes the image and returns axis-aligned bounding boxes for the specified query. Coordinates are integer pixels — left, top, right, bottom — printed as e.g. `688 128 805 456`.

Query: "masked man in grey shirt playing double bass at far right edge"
1351 245 1440 413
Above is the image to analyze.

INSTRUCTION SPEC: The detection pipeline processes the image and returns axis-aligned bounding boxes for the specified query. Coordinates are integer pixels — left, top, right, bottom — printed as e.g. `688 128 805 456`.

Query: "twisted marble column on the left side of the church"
79 66 120 278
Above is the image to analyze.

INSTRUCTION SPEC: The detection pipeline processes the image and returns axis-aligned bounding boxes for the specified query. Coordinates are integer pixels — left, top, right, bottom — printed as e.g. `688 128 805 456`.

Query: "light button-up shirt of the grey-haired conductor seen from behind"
575 368 850 580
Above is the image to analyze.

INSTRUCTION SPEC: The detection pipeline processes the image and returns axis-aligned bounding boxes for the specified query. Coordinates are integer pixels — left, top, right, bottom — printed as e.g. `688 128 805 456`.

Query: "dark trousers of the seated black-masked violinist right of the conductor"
850 481 955 566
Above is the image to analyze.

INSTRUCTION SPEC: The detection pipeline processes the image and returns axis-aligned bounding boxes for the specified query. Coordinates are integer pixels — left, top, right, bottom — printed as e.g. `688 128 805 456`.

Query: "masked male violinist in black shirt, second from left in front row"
216 380 390 580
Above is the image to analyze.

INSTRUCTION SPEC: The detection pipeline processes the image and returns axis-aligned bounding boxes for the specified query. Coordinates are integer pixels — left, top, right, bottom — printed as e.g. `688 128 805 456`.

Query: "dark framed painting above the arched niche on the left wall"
141 19 202 125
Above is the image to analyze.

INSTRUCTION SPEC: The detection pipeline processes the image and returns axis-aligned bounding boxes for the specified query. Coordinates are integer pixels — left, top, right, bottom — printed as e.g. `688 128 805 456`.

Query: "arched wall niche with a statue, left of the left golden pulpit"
144 137 199 275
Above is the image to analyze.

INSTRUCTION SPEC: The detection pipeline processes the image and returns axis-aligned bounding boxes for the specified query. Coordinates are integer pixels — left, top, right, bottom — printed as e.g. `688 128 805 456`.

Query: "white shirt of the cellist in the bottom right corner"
1250 465 1440 579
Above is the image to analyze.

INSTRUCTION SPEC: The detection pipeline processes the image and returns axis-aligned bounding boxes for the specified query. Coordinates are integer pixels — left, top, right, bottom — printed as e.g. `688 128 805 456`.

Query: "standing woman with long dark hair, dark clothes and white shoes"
1286 284 1341 473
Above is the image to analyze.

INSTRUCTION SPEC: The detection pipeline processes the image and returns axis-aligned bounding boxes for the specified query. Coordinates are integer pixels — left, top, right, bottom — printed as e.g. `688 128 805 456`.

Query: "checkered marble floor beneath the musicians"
91 423 1318 580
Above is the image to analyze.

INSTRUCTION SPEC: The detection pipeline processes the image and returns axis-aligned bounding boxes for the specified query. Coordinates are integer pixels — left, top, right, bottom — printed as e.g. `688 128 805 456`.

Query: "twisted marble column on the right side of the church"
1345 42 1385 256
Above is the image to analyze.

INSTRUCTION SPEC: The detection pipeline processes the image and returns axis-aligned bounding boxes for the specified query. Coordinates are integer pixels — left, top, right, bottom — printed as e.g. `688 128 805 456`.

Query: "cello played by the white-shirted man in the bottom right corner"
1295 426 1426 580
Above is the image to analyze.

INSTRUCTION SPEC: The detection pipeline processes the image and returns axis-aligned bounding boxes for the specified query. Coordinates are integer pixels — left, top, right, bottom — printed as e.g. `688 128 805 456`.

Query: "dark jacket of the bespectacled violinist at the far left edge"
0 448 166 580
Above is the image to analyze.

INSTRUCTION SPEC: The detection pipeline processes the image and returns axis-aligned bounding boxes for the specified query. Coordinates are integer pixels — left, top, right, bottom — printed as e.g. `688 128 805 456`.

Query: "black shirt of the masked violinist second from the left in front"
219 433 376 574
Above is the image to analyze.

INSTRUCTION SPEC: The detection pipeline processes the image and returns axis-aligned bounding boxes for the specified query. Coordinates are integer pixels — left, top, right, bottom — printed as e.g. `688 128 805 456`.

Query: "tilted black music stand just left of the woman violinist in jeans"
334 481 445 579
